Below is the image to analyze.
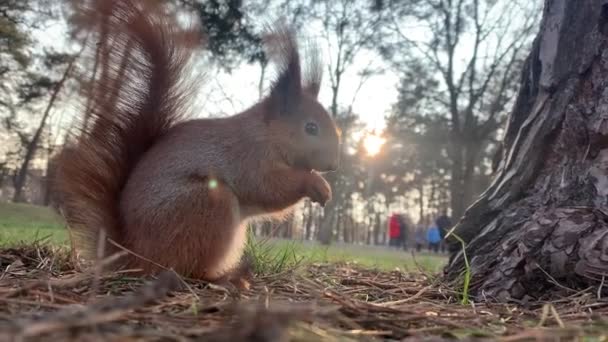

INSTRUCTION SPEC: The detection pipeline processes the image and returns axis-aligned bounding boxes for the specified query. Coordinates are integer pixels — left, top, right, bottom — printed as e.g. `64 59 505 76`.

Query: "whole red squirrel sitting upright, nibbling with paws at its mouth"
54 0 341 281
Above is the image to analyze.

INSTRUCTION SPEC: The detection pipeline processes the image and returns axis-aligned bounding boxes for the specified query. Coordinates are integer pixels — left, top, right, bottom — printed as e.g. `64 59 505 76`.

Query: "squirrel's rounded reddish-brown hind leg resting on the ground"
125 177 247 281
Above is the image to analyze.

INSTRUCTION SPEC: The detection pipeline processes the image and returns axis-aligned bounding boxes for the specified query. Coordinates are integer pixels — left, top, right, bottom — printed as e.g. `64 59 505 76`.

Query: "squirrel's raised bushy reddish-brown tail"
52 0 199 254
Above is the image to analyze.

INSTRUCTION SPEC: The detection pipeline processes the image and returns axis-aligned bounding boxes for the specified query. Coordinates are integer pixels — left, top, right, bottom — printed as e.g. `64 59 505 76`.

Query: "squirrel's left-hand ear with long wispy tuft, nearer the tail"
265 23 302 116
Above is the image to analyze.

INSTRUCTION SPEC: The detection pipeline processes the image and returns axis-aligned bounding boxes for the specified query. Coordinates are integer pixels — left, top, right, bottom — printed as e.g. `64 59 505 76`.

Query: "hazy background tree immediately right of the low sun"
386 65 451 220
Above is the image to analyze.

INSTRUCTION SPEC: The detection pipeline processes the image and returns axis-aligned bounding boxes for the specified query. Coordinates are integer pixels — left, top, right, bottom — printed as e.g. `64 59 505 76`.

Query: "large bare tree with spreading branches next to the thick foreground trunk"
382 0 538 217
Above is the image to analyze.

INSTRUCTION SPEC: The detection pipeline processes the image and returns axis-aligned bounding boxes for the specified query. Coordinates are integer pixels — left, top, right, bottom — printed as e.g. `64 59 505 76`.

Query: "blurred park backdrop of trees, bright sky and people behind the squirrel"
0 0 542 252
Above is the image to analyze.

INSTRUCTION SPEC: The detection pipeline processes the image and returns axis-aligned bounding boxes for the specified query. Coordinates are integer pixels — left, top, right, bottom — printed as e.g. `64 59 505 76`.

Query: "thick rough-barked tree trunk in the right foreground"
445 0 608 301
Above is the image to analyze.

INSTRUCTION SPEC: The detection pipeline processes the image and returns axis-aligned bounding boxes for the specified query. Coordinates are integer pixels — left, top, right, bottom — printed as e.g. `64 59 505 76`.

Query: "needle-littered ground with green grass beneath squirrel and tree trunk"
0 204 608 341
